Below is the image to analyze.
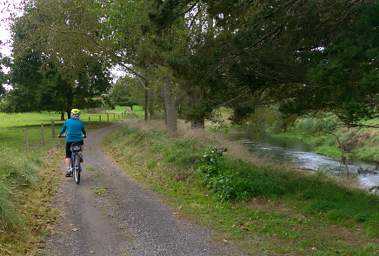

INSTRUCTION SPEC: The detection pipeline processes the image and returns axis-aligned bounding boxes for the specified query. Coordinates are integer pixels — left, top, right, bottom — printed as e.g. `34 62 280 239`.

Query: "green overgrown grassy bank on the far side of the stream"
212 107 379 162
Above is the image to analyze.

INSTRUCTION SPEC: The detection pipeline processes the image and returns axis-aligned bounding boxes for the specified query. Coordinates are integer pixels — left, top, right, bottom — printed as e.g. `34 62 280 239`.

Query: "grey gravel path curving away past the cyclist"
45 125 244 256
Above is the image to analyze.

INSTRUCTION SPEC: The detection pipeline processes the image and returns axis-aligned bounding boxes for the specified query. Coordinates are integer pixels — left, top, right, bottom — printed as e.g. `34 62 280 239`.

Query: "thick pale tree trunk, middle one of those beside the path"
162 78 178 135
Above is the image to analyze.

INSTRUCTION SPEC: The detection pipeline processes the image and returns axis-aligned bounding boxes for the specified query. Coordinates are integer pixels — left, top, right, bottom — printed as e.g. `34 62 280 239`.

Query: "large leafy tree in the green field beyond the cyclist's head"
9 1 110 118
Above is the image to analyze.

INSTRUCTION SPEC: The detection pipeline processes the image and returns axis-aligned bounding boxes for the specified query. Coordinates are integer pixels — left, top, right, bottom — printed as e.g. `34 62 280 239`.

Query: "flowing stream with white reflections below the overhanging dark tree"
241 138 379 190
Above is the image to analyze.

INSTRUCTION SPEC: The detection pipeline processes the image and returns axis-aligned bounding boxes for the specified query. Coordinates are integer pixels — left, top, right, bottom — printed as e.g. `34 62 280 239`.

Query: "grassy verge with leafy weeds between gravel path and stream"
105 128 379 255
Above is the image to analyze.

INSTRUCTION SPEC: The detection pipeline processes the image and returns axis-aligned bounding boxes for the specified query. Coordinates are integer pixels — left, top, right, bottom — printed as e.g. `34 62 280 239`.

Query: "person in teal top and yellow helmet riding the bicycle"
59 108 87 177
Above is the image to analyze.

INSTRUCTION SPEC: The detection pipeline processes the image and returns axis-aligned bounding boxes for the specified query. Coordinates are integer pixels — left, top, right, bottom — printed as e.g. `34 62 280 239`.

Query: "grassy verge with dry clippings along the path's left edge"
0 149 62 256
